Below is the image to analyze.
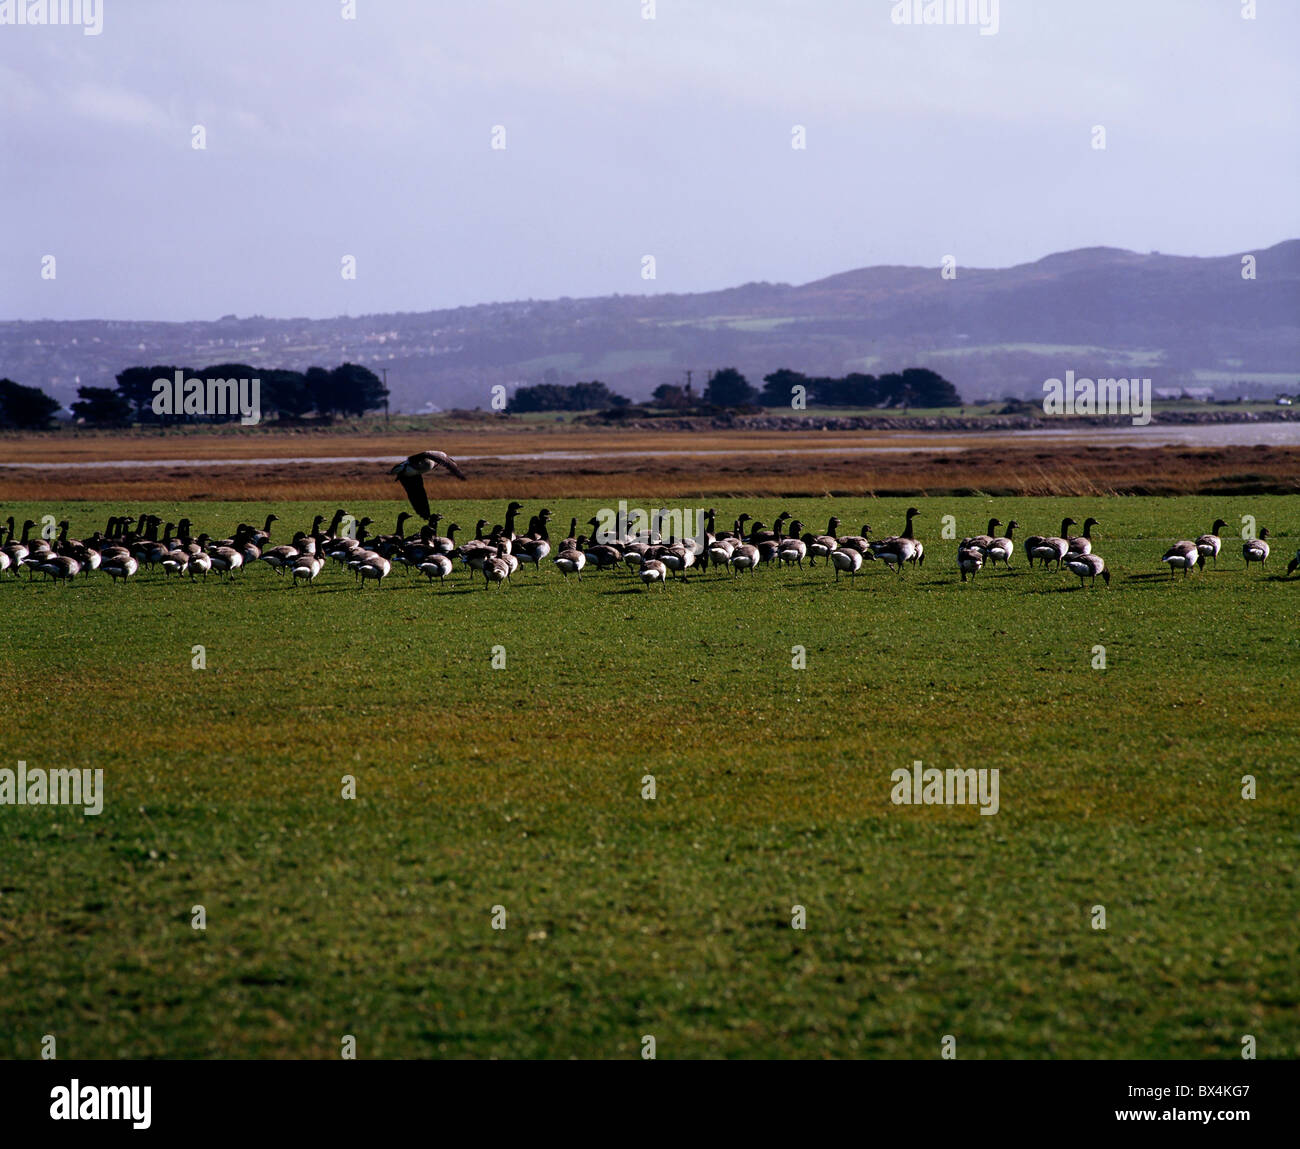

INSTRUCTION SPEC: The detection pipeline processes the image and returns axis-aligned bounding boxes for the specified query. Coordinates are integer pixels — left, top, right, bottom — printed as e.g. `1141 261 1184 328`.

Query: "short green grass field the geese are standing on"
0 491 1300 1058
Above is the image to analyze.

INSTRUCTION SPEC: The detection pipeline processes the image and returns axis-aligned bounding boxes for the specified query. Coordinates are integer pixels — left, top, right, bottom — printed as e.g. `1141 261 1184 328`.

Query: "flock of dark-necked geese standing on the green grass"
0 504 1300 587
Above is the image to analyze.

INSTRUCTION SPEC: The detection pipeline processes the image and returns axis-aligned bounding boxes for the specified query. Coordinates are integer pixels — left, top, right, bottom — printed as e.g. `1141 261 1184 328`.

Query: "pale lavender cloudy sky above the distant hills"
0 0 1300 320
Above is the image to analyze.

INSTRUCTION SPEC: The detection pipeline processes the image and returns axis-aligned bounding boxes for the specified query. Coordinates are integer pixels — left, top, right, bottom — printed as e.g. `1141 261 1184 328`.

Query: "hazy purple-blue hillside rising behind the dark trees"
0 239 1300 411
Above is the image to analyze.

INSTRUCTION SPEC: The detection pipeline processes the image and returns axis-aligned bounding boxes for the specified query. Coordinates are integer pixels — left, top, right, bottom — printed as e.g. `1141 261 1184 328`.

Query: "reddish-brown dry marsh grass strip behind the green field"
0 441 1300 502
